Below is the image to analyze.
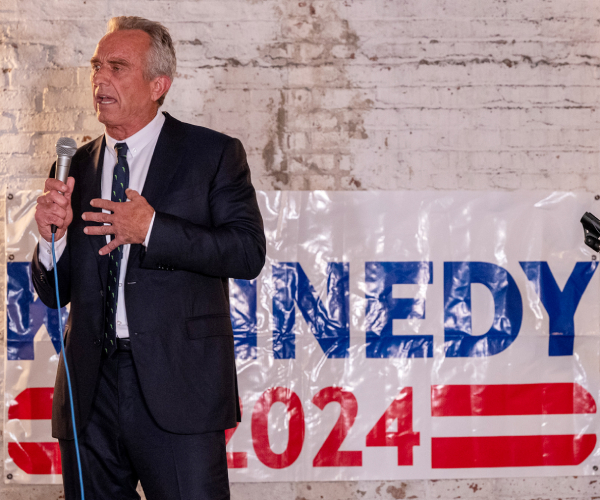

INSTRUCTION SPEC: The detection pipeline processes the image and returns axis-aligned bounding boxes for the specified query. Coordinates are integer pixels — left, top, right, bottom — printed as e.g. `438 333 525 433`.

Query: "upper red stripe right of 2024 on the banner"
431 383 596 417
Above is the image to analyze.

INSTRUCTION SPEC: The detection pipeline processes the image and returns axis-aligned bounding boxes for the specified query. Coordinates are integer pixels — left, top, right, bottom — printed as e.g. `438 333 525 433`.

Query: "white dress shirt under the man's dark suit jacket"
38 110 165 338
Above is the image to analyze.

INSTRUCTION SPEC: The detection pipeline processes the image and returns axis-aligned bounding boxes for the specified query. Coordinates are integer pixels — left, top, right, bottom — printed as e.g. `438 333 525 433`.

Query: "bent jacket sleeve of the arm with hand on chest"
141 139 266 279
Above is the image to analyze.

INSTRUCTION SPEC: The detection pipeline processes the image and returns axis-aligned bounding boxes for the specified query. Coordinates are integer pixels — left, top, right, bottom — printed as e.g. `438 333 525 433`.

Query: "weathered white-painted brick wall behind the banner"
0 0 600 500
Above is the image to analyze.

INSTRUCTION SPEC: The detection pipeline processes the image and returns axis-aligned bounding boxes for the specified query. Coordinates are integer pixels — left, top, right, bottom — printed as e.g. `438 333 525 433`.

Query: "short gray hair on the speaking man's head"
106 16 177 106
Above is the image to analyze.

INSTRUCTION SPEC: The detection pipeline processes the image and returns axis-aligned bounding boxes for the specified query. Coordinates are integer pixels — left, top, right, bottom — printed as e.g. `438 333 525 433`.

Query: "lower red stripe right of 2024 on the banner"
431 434 596 469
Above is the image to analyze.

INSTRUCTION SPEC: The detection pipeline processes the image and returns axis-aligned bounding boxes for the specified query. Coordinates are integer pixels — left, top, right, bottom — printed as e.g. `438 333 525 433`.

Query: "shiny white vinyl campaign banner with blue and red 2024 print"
4 191 600 483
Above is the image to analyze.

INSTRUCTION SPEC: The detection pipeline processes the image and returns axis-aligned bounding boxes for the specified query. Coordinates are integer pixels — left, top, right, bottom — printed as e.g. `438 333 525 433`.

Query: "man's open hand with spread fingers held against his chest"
81 189 154 255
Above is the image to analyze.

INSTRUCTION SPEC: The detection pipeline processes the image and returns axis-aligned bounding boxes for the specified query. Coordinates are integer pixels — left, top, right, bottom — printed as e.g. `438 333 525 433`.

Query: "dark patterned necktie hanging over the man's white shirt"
104 142 129 356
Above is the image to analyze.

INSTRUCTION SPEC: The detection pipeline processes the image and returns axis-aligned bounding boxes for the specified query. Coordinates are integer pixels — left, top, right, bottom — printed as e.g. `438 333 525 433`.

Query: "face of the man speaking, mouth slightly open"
90 30 160 139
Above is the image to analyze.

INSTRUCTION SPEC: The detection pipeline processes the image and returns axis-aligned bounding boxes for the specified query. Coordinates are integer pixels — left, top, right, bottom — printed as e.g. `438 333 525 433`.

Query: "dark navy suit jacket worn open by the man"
32 113 265 439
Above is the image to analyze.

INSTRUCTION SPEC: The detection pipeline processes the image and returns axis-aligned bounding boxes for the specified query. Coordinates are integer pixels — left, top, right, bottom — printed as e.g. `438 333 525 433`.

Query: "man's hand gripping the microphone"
35 177 75 241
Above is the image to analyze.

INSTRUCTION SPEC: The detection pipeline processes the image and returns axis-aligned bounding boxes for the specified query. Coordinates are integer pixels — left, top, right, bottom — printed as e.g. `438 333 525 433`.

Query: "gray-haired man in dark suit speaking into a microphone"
33 17 265 500
